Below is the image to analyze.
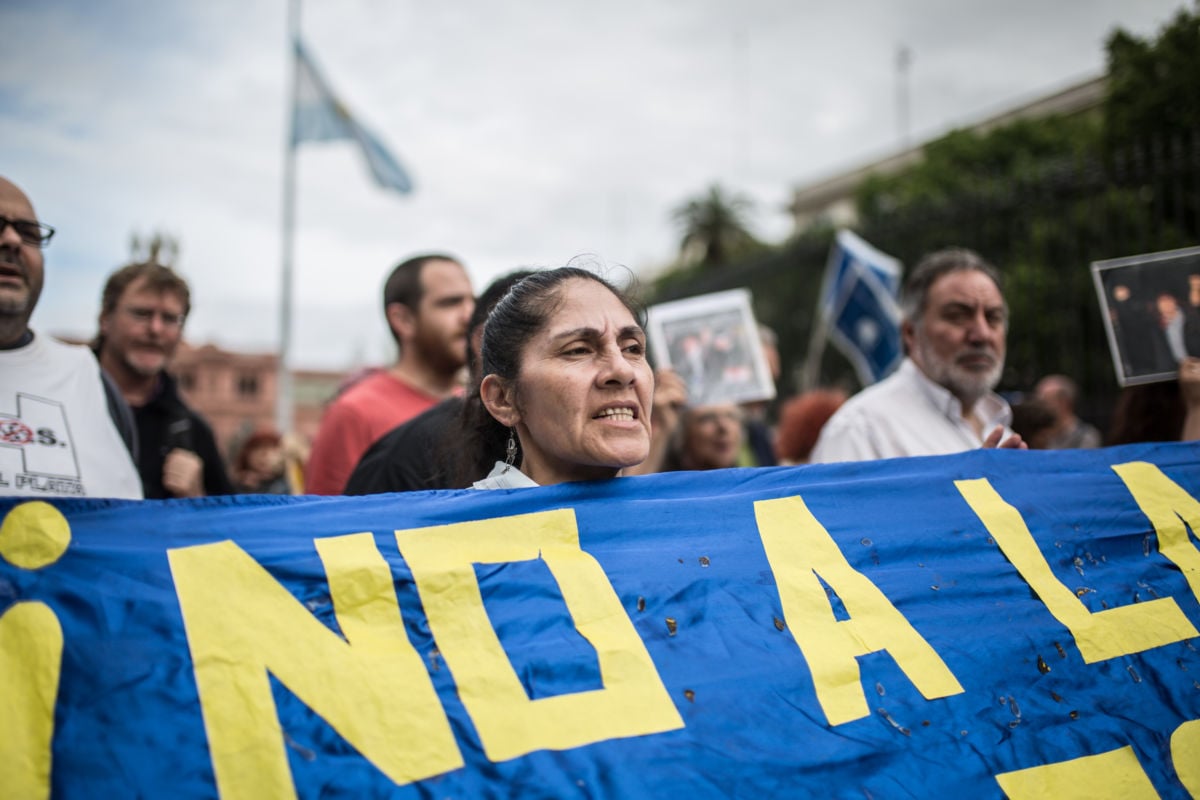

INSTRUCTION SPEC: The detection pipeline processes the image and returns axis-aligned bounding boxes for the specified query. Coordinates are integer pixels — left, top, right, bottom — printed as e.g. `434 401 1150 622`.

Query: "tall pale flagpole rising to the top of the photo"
275 0 300 434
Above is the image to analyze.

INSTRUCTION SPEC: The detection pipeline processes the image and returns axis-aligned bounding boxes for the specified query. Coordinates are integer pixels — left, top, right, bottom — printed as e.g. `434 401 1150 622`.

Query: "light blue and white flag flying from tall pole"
292 38 413 194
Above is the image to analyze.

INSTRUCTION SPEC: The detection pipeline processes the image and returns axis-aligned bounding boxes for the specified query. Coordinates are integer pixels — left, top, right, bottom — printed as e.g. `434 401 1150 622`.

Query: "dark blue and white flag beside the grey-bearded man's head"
820 230 904 386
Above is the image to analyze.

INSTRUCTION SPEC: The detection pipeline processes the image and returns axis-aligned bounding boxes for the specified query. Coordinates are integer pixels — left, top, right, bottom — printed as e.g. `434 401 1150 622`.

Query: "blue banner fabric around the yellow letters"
0 444 1200 799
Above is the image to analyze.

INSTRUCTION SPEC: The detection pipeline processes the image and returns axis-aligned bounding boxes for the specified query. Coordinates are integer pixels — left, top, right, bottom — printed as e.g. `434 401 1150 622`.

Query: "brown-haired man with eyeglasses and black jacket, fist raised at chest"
92 261 234 499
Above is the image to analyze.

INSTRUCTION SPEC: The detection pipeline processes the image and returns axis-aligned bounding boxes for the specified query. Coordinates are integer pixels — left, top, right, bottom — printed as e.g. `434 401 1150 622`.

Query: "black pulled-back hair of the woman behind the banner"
455 266 644 487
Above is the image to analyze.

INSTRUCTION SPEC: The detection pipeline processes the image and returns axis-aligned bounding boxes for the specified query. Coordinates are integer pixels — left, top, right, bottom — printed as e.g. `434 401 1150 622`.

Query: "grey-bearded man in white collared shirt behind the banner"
812 247 1025 463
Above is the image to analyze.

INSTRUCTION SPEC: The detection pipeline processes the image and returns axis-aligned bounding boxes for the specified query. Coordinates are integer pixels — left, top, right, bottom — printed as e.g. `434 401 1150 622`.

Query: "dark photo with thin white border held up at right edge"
1092 247 1200 386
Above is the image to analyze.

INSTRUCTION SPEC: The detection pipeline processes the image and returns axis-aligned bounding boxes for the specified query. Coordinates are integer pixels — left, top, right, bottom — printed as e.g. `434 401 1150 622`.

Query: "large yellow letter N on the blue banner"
168 534 462 800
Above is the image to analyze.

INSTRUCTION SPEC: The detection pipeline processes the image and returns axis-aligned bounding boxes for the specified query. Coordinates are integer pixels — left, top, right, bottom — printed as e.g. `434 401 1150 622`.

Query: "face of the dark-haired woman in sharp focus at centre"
485 278 654 486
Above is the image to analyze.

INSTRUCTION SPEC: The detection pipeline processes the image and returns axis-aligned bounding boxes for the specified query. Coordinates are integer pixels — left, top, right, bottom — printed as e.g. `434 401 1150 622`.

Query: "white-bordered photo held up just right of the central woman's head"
646 289 775 407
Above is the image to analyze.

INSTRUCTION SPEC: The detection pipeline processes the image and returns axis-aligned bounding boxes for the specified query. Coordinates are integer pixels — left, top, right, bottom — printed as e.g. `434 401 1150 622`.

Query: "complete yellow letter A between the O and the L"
754 497 962 724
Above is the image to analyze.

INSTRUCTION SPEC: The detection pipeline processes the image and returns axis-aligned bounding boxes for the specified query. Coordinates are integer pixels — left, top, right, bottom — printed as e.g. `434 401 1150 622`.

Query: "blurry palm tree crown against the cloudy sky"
671 184 760 266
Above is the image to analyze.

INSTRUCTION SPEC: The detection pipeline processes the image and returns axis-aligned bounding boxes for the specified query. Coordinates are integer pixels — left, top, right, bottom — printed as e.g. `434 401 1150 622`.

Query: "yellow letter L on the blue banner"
954 477 1200 663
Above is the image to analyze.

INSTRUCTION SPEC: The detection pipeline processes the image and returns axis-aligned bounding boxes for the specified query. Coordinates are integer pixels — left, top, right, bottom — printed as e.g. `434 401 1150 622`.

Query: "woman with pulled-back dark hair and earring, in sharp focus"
460 266 654 488
